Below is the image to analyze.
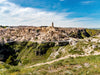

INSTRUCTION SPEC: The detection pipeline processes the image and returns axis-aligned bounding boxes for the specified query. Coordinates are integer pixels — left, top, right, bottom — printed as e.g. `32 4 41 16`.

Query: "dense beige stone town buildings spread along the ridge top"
0 26 89 44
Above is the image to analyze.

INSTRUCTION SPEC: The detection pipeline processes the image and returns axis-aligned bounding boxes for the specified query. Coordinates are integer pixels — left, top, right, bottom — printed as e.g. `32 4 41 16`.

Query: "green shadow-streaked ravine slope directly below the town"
4 42 54 65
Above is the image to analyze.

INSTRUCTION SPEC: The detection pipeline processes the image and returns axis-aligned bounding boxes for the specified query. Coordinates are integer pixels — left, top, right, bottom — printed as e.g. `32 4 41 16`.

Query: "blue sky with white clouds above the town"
0 0 100 28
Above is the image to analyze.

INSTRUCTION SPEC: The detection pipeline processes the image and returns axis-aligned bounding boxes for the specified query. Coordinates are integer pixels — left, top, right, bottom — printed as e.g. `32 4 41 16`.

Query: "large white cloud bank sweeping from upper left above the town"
0 0 94 27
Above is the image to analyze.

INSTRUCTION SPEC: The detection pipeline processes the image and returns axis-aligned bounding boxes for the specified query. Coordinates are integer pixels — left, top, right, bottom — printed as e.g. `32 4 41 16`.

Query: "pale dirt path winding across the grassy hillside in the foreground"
27 52 100 68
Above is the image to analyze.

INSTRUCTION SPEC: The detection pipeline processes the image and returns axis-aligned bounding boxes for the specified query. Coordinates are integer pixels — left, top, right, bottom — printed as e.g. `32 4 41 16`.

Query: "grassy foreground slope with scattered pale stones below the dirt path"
2 55 100 75
